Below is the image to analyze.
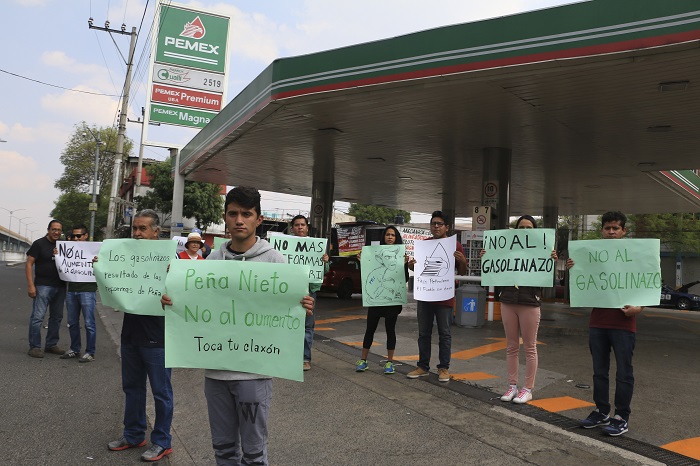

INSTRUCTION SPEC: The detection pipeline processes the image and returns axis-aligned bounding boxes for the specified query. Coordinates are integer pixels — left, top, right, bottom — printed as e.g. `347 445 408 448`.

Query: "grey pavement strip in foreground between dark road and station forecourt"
94 300 663 466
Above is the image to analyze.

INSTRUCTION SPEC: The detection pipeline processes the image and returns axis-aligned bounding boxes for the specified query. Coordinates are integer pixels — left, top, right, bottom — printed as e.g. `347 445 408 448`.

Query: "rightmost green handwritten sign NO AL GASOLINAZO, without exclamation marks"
569 239 661 308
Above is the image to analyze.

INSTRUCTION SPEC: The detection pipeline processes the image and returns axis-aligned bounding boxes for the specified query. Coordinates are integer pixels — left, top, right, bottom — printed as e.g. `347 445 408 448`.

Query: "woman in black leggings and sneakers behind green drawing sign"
355 226 408 374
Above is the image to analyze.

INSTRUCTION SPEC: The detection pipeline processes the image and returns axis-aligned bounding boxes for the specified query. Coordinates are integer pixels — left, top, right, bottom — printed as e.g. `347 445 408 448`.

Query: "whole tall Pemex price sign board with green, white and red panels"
148 2 229 128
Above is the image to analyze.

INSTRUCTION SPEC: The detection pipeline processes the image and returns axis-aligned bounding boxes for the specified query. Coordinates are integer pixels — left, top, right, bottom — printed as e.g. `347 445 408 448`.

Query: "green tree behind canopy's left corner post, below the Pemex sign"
134 159 224 230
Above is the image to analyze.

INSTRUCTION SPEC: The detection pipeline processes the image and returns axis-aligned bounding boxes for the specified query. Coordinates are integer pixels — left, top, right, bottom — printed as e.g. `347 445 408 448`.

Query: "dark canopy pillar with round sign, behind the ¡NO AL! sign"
481 147 511 230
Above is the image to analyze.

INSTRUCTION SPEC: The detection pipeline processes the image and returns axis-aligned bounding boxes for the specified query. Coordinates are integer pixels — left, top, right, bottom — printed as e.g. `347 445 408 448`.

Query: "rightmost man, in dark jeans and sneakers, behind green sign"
566 212 643 436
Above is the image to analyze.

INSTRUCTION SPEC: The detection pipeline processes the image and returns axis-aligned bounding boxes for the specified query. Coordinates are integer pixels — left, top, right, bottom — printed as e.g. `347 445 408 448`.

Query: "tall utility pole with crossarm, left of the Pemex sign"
88 18 136 238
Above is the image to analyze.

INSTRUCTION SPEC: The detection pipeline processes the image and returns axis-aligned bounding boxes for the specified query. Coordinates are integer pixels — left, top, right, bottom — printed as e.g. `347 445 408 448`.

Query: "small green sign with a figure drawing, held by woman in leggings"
360 244 406 307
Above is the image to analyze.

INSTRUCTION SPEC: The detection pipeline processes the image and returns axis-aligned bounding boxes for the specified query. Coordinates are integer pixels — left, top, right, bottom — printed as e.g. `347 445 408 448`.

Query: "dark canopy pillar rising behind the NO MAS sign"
309 129 336 240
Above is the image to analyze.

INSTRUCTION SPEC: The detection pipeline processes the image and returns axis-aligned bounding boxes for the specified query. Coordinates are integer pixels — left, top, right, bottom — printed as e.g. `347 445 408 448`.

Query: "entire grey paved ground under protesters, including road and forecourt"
0 264 700 466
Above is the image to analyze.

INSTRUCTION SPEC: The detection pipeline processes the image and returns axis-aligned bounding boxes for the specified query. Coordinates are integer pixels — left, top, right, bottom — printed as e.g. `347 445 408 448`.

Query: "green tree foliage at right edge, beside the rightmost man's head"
627 213 700 254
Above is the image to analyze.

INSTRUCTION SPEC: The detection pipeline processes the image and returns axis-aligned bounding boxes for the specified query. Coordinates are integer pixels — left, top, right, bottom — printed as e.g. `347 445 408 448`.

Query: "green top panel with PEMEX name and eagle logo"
155 5 229 73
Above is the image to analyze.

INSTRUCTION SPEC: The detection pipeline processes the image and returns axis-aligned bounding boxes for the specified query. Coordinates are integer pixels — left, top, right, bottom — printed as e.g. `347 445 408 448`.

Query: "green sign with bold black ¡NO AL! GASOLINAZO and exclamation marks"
481 228 555 287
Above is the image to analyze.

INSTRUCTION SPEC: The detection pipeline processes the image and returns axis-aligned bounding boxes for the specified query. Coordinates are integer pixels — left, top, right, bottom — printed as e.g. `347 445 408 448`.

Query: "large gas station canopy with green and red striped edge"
179 0 700 216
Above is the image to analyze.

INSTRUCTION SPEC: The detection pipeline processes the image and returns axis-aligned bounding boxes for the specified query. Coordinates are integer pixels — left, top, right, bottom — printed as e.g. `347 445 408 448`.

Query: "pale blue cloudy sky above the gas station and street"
0 0 572 240
